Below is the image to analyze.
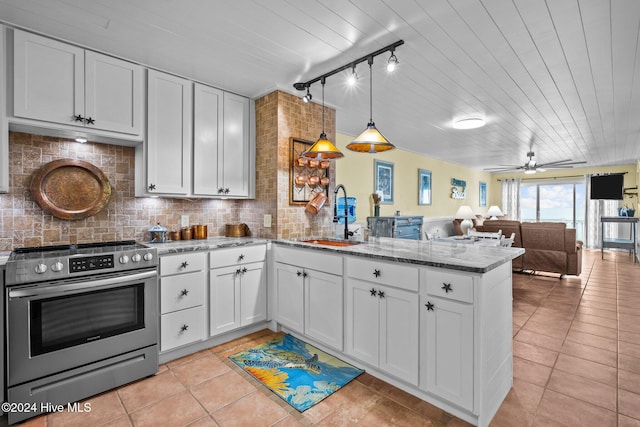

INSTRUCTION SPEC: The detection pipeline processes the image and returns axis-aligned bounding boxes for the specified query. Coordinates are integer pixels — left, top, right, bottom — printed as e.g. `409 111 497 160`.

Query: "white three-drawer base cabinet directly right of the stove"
160 252 207 352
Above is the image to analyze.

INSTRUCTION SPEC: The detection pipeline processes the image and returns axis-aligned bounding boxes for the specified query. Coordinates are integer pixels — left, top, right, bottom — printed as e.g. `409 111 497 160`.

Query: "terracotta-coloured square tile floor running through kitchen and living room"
5 251 640 427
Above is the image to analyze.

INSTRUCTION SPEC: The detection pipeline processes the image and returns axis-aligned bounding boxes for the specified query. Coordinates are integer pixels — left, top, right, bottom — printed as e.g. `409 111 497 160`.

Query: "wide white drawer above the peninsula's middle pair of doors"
347 258 420 292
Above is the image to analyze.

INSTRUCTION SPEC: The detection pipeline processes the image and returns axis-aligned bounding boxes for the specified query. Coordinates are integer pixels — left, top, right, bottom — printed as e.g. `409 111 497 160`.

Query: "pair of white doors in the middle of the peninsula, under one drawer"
345 276 419 385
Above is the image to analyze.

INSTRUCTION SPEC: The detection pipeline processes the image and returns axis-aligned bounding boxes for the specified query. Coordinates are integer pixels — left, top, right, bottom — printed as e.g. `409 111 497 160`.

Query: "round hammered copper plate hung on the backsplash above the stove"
31 159 111 219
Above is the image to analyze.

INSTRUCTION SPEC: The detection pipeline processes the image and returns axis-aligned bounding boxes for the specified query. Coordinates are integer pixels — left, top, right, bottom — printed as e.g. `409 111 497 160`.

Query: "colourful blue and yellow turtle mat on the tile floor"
229 334 364 412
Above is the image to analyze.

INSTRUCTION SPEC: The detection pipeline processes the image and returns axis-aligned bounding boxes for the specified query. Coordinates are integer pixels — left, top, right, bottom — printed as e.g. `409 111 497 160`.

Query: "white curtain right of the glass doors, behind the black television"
584 175 620 248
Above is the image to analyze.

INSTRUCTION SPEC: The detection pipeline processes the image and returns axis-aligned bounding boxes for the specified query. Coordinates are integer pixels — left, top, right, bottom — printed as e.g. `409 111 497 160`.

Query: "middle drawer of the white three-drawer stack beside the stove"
160 271 206 314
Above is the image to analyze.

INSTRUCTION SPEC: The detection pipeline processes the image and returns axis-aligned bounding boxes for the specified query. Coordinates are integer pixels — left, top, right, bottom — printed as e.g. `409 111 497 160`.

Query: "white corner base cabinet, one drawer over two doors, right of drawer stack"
209 245 267 336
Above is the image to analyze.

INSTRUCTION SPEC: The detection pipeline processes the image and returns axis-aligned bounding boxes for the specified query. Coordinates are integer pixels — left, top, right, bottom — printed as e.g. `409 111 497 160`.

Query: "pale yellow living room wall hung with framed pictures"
332 133 500 221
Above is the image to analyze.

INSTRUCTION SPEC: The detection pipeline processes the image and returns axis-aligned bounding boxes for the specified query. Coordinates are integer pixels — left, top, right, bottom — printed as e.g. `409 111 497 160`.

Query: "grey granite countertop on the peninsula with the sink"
273 237 524 273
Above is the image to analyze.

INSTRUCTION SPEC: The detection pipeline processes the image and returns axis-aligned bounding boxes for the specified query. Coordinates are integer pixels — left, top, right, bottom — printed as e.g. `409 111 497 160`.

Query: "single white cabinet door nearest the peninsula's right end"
420 295 473 410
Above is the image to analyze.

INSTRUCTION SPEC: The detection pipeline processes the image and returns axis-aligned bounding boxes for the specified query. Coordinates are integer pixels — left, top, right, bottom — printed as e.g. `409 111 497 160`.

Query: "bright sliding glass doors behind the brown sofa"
520 179 586 240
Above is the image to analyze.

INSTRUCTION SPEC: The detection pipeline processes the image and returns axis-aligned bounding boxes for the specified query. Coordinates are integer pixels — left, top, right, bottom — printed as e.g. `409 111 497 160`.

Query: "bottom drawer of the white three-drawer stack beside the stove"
160 306 205 351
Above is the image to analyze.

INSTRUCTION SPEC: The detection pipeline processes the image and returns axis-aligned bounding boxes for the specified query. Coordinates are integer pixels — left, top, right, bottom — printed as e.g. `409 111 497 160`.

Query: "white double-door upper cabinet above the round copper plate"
13 30 144 136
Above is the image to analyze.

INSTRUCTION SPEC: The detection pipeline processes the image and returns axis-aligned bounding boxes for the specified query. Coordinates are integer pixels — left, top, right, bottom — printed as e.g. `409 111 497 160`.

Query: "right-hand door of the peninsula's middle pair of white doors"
379 287 420 385
